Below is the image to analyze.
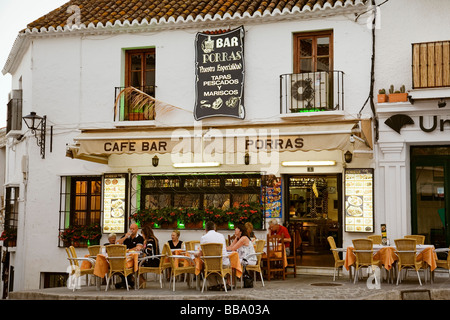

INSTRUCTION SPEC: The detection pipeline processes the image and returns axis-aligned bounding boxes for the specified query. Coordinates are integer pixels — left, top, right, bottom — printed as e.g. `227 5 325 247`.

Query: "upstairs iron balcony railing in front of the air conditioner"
280 71 344 114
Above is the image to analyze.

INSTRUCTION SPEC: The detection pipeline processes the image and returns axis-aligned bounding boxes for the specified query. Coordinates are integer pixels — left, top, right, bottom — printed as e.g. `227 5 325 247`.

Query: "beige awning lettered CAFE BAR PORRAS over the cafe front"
67 120 372 163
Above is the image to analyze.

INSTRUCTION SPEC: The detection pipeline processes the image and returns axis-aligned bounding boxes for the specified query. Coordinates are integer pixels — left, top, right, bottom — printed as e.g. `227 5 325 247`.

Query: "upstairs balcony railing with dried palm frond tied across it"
114 86 155 121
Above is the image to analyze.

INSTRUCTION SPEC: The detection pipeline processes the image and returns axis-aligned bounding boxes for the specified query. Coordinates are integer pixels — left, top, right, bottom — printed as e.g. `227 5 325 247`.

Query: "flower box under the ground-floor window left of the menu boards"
59 223 102 247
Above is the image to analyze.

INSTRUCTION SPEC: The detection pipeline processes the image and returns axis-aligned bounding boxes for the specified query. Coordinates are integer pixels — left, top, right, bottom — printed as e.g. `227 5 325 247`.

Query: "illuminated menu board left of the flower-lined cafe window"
103 174 127 233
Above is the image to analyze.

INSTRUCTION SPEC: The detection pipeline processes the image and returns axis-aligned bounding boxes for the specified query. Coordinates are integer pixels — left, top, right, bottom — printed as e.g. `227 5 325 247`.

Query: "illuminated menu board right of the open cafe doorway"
345 169 374 232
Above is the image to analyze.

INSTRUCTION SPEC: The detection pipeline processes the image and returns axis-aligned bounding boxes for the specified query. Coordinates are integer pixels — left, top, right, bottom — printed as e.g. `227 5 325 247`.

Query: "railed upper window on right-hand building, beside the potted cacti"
412 41 450 89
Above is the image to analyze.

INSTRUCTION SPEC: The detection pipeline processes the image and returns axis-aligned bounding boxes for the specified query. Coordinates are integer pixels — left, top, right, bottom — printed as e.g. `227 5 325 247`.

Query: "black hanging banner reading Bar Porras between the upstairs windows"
194 27 245 120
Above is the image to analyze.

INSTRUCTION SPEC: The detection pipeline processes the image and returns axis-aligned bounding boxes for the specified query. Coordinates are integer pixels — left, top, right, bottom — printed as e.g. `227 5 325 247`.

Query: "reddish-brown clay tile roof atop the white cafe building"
24 0 367 30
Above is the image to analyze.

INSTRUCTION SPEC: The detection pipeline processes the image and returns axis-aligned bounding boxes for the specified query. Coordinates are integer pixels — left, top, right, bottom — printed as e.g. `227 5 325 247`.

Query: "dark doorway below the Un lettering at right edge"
411 147 450 248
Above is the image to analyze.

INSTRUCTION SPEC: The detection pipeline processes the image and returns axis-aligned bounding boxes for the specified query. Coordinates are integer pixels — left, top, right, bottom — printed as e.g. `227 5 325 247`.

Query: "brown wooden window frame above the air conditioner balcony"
294 30 334 73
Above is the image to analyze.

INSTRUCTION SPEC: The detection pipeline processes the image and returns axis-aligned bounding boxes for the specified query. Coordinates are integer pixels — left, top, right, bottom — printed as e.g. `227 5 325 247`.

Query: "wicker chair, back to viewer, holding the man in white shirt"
201 243 232 292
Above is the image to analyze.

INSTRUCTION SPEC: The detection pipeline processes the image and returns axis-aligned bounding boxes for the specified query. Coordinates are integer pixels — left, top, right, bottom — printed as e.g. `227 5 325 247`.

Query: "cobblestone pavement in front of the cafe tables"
9 272 450 301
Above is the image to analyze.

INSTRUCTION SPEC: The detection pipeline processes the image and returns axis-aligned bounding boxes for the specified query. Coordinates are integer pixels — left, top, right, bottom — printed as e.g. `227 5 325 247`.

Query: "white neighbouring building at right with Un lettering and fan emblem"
375 1 450 247
